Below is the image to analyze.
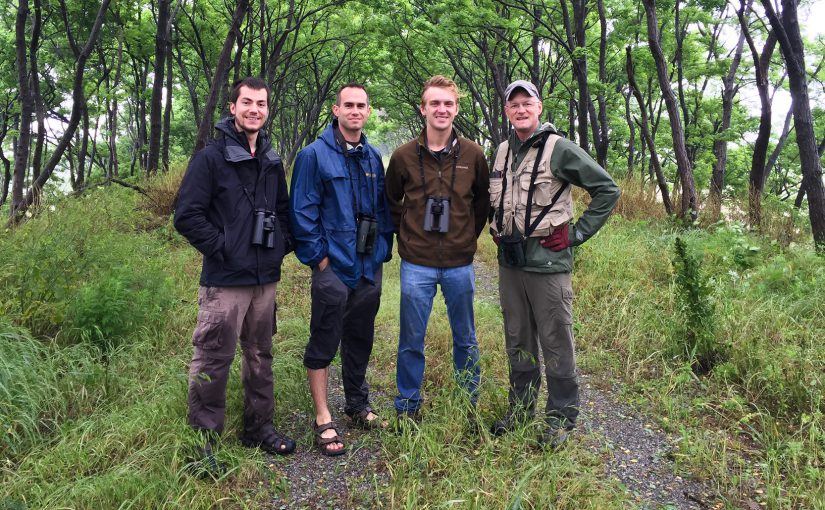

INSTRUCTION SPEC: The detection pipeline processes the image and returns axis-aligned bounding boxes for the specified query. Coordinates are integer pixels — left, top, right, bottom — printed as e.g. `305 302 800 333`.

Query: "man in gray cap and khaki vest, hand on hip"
490 80 620 448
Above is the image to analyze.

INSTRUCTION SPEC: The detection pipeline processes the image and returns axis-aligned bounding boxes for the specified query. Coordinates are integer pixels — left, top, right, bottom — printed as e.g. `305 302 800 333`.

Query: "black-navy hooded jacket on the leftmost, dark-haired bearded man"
175 117 291 287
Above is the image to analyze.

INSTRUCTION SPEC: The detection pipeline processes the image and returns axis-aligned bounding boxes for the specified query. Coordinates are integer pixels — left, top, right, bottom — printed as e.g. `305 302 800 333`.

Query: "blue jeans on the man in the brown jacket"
395 260 480 413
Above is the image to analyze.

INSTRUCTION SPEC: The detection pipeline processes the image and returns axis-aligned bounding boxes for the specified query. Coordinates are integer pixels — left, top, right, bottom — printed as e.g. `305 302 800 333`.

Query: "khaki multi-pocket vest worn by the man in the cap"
490 135 573 237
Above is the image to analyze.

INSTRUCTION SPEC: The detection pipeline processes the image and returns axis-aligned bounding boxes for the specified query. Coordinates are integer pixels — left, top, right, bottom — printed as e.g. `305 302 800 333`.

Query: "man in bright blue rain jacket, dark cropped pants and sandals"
291 83 392 456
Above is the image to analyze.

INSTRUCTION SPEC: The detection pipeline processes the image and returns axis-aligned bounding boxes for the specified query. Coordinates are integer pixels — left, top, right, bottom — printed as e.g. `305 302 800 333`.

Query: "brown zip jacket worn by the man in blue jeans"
385 132 490 267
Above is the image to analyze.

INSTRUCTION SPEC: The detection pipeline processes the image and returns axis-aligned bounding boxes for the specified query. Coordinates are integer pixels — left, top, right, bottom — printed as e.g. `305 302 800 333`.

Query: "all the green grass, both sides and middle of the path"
0 177 825 509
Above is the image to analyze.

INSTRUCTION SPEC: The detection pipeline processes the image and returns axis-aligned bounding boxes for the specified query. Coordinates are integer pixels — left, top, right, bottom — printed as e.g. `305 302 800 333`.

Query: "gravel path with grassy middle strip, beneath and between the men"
258 257 722 509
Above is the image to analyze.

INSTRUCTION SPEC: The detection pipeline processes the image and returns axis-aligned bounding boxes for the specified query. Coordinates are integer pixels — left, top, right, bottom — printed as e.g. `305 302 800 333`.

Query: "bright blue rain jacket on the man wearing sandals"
290 121 393 288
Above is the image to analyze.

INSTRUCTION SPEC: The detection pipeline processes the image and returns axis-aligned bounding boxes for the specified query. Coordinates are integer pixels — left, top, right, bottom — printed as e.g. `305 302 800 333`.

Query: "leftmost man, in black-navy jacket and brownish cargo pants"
175 77 295 469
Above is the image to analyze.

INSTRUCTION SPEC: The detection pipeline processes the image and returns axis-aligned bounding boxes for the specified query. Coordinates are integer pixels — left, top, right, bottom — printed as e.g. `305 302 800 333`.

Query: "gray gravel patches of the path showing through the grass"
256 265 721 510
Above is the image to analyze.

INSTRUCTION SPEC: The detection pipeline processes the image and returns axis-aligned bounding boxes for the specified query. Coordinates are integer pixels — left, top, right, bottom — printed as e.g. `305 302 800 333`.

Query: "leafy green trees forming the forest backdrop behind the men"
0 0 825 247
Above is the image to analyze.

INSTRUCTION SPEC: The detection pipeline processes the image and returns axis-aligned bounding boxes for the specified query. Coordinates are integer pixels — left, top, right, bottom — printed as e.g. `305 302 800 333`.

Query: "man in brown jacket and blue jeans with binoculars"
385 76 490 417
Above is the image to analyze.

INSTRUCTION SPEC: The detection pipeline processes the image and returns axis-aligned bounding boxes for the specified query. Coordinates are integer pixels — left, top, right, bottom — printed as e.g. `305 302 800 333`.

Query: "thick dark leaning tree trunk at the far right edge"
762 0 825 249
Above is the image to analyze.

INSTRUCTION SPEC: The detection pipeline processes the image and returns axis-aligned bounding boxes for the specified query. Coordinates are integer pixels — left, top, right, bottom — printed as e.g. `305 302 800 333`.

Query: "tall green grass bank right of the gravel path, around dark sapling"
575 217 825 508
